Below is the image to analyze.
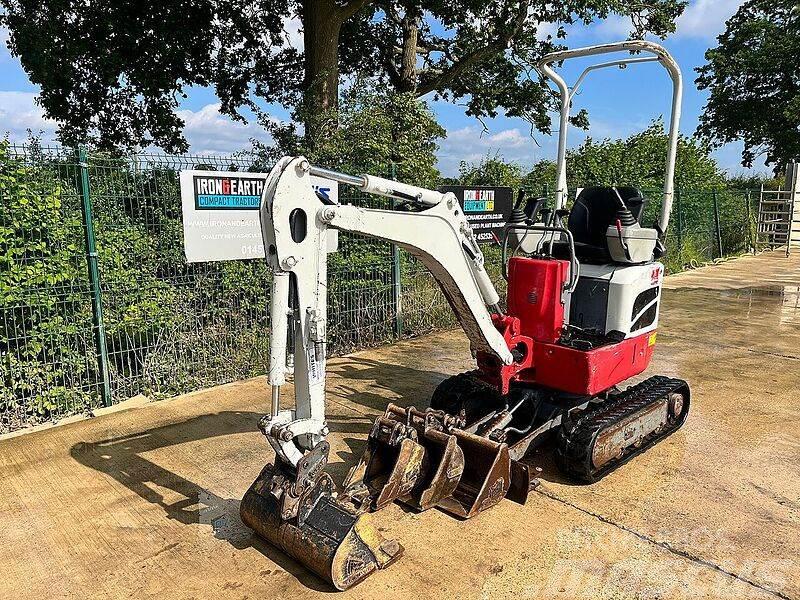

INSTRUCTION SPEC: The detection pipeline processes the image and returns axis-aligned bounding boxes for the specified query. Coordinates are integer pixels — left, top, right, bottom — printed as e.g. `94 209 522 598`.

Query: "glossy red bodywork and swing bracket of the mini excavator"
477 257 656 396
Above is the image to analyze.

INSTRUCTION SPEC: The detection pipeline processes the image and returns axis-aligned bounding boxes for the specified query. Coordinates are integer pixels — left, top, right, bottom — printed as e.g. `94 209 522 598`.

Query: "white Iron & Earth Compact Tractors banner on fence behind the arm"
180 171 339 263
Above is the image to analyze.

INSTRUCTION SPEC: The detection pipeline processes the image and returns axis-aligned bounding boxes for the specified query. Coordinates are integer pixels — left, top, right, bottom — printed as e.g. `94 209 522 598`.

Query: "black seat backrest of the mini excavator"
567 186 645 254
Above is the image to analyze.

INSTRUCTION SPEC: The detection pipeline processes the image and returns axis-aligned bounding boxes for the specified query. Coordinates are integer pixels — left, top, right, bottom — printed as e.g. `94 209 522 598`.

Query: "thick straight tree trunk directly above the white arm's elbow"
302 0 342 143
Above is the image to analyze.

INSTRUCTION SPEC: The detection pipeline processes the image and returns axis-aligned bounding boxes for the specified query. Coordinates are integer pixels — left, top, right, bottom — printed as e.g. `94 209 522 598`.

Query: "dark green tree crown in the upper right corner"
697 0 800 174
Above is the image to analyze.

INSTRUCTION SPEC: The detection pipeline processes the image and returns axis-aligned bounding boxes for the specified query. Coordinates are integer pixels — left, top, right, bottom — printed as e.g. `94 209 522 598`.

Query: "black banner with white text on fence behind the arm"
439 185 514 244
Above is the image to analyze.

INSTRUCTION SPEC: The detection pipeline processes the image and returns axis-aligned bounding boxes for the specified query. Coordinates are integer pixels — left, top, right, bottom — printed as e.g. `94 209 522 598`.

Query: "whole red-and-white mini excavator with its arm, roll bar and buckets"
240 40 689 590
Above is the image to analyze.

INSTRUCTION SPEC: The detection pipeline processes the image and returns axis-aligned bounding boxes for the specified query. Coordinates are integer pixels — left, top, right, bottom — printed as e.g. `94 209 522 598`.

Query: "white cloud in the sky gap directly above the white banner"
178 103 270 154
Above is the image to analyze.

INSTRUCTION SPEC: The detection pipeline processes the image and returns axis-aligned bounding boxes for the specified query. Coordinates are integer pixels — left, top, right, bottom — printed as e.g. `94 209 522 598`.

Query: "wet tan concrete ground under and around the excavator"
0 254 800 599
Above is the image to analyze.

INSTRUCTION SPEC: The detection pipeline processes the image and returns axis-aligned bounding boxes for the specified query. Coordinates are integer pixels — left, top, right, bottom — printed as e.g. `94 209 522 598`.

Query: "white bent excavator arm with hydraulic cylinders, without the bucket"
261 157 513 467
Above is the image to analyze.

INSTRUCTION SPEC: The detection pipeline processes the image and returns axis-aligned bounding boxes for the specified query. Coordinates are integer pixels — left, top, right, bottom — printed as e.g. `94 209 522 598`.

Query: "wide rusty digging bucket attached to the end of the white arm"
239 465 403 590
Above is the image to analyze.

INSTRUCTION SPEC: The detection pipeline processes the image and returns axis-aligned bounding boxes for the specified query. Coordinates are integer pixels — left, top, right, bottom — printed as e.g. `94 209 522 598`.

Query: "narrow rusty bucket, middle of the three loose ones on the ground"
401 429 464 510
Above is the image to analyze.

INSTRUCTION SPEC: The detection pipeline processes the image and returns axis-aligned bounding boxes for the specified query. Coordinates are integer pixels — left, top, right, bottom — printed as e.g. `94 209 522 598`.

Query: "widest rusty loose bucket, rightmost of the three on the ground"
438 429 511 519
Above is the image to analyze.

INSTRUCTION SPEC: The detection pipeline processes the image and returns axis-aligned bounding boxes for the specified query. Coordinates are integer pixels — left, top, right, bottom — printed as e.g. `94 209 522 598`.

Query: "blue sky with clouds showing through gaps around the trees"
0 0 766 175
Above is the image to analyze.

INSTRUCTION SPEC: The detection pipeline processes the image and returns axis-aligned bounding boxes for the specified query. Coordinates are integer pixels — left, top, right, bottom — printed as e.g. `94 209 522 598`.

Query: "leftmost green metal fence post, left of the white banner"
78 146 111 406
